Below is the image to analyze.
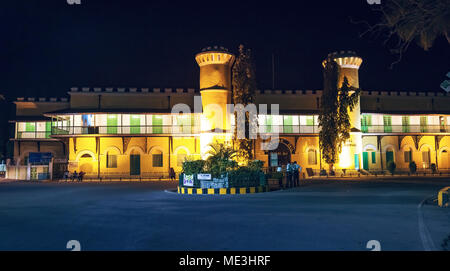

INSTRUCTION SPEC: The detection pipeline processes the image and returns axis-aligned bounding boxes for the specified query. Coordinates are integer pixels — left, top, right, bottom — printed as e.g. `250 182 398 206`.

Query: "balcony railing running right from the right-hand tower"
361 125 450 134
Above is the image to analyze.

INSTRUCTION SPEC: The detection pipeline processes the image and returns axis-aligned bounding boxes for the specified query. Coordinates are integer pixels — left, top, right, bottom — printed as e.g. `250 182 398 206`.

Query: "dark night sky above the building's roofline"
0 0 450 99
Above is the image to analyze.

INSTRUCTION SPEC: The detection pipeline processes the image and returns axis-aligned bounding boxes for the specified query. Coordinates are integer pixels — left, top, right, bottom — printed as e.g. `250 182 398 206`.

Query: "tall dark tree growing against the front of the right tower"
319 60 360 172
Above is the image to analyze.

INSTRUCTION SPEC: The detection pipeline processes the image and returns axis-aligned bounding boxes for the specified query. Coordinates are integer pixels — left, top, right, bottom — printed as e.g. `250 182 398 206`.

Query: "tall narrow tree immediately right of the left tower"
233 44 256 164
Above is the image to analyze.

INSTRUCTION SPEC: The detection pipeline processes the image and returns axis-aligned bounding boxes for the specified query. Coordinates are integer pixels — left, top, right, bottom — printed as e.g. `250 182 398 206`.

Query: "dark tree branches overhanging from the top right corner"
356 0 450 64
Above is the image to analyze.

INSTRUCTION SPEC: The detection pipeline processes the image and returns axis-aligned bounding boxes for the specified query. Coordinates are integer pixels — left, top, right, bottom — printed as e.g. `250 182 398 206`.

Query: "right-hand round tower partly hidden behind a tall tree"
322 51 362 169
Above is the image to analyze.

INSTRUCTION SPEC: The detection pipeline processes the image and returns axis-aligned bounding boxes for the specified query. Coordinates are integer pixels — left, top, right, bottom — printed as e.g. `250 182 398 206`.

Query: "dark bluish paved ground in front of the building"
0 179 450 250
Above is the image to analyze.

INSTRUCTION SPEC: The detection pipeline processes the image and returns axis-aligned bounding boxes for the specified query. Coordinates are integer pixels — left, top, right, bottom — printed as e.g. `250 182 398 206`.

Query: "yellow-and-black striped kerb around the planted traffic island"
178 186 270 195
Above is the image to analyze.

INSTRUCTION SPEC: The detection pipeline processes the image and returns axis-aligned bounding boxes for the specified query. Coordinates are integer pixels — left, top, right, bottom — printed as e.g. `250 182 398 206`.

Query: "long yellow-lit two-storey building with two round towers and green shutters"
8 47 450 179
